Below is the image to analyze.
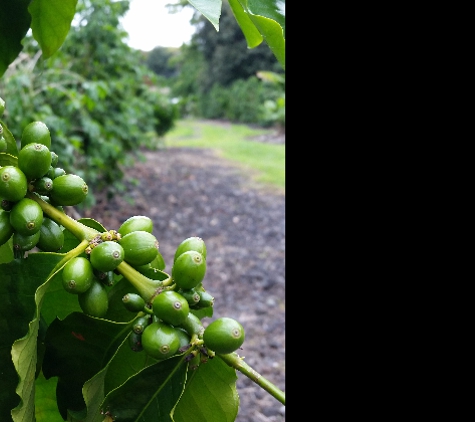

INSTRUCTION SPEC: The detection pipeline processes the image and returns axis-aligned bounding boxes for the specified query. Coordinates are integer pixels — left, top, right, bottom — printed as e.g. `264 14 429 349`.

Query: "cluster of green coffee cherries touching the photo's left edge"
0 116 88 257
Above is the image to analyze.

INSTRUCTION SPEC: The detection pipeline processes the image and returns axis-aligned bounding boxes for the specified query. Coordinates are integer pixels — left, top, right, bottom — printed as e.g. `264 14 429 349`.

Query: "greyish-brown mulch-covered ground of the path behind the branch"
84 126 285 422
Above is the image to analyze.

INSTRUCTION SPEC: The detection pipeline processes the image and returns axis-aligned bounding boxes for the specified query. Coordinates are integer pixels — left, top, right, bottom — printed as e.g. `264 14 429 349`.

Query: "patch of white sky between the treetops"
121 0 195 51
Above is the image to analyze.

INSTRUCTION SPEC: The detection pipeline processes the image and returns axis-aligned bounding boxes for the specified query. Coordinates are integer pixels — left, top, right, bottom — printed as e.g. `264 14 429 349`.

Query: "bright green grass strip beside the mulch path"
164 119 285 189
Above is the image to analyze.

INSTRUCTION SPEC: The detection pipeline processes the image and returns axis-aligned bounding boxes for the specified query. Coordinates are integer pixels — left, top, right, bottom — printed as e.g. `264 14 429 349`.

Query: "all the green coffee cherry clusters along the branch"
0 98 245 367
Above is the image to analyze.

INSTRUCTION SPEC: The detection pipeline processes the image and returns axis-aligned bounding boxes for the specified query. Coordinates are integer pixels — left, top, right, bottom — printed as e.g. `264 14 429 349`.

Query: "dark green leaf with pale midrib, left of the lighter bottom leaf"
102 356 187 422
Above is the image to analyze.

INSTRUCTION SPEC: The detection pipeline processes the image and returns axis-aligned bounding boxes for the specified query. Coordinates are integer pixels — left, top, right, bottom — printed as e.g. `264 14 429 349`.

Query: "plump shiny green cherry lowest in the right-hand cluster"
142 321 180 360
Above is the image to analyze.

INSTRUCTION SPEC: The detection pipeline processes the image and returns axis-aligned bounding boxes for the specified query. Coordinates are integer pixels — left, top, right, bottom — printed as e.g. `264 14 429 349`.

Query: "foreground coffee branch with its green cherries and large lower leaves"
0 98 285 422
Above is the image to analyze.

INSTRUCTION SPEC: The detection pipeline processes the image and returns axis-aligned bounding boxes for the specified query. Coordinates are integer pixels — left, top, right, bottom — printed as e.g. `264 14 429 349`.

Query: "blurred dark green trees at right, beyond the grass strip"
170 2 285 126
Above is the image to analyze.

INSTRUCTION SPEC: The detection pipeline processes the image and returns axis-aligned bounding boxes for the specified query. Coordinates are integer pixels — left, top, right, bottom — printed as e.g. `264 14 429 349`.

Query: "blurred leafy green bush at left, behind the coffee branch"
0 0 177 205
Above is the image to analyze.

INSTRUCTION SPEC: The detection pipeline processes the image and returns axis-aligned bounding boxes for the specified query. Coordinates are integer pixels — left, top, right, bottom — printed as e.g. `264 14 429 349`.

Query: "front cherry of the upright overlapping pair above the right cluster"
172 251 206 290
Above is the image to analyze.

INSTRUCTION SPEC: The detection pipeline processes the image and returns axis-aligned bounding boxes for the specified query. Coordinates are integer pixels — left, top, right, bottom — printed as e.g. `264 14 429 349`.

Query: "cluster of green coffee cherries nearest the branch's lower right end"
122 236 245 362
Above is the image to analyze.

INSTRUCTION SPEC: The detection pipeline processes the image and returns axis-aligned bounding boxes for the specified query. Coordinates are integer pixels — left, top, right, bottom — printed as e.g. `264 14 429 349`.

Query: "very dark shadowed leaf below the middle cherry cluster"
43 312 131 419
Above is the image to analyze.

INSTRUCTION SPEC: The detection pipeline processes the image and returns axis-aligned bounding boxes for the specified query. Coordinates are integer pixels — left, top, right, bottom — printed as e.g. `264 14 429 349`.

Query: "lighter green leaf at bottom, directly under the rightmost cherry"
172 358 239 422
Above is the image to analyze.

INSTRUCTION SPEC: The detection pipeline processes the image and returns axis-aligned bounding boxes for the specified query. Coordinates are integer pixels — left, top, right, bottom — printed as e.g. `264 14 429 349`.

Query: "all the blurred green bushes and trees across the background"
0 0 285 207
